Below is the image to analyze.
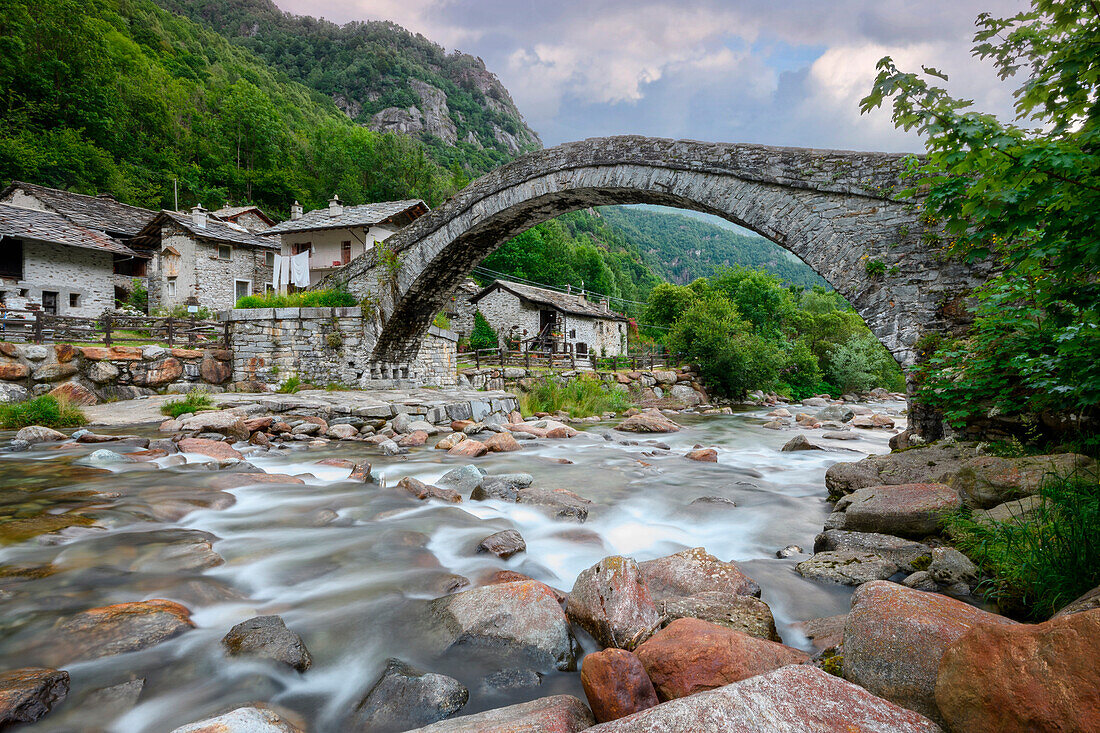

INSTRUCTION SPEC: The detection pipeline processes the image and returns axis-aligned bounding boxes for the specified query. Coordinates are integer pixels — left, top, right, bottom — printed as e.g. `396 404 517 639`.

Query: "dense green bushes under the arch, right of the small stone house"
644 267 905 400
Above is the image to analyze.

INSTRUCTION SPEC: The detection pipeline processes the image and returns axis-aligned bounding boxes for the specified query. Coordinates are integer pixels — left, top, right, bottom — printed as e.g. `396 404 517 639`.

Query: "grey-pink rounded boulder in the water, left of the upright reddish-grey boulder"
429 581 575 670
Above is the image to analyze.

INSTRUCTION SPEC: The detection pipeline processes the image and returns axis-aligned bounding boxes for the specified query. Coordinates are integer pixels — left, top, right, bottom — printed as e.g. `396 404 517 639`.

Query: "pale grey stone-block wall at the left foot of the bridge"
225 307 458 390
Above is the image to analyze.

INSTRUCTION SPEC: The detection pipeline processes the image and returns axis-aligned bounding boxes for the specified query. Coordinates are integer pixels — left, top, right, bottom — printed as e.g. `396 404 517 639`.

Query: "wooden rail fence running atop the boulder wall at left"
0 308 229 349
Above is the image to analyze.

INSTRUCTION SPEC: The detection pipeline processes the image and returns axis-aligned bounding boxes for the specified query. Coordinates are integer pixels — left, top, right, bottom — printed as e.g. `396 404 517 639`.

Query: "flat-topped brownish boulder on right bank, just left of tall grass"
825 483 963 537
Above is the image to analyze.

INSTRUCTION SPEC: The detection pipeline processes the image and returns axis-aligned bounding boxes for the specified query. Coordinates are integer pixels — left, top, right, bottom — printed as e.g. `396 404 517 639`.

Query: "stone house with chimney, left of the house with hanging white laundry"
134 206 278 313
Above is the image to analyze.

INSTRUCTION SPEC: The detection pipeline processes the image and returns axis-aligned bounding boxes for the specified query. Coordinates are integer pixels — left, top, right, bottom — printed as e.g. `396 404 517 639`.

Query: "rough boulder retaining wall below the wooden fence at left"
0 341 232 405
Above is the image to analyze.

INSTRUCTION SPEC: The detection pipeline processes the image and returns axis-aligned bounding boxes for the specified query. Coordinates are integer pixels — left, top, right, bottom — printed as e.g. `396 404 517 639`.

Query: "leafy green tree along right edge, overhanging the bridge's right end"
862 0 1100 448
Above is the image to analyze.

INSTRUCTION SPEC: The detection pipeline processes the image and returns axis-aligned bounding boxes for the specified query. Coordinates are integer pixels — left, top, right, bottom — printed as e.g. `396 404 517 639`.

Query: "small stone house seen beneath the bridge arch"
464 280 627 357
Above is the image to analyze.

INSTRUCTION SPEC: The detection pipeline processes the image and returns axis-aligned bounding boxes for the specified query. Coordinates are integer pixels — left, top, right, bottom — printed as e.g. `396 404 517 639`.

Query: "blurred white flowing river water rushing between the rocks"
0 403 904 733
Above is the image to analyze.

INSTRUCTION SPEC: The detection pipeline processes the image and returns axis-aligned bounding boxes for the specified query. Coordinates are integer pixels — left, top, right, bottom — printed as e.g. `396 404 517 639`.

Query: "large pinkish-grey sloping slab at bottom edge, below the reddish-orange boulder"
590 665 942 733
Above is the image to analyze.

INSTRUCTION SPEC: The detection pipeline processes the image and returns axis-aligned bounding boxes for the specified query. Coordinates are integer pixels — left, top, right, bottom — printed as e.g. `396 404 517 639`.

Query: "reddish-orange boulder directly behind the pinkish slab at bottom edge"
636 619 810 700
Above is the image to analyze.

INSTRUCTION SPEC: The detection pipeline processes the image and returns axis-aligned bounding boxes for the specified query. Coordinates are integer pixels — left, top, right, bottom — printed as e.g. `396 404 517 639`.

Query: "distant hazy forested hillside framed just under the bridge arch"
600 206 826 287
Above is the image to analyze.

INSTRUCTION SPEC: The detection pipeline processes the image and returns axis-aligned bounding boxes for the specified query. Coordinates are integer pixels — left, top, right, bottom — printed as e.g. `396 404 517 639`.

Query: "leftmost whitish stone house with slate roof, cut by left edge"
0 204 146 317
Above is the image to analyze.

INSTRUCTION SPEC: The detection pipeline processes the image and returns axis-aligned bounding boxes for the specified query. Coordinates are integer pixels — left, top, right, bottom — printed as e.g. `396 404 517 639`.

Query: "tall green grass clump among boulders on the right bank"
948 468 1100 620
